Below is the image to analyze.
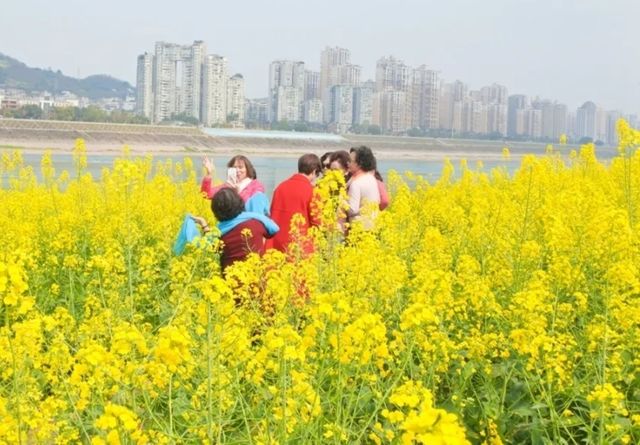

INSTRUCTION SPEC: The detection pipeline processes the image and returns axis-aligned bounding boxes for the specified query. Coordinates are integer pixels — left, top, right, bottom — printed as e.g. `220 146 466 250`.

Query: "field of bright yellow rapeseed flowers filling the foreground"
0 121 640 444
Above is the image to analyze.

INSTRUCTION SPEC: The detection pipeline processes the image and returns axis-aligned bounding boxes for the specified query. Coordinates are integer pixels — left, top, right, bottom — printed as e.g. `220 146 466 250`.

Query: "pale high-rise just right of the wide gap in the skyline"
269 60 306 122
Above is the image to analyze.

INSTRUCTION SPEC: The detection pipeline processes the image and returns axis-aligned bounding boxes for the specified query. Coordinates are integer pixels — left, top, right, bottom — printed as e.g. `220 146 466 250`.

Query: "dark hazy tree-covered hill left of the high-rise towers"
0 53 135 99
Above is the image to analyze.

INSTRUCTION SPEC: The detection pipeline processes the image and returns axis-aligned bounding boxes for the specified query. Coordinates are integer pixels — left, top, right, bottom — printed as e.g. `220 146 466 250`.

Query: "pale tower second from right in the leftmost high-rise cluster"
202 54 229 126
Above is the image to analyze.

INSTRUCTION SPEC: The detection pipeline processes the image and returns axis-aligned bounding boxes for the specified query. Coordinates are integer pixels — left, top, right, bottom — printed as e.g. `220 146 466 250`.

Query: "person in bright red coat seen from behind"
268 154 321 253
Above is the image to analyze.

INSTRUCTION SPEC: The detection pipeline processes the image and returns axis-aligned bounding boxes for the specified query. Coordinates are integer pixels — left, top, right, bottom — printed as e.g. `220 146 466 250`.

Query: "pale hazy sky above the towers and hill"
0 0 640 113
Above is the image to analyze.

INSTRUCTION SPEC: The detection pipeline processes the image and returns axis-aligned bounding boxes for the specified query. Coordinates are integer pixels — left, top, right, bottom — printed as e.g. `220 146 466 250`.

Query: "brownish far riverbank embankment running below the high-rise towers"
0 119 596 161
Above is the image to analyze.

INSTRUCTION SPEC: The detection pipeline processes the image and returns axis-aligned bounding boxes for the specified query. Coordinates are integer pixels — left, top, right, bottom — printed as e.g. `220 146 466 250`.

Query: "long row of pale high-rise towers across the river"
130 40 638 144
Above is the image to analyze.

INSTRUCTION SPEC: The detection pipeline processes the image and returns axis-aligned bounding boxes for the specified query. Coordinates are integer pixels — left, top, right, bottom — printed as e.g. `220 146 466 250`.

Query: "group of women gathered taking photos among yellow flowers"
192 146 389 273
